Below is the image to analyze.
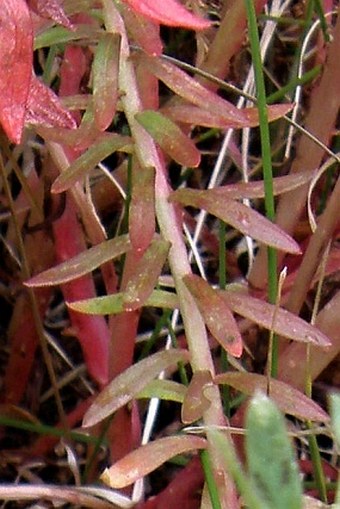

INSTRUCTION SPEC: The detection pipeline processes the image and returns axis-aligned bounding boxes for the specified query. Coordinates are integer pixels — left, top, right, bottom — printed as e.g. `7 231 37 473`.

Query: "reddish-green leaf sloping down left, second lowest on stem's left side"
83 350 189 428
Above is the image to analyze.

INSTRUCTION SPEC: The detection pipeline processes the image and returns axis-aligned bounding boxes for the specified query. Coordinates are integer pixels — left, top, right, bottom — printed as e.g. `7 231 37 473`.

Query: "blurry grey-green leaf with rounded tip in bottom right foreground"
246 393 302 509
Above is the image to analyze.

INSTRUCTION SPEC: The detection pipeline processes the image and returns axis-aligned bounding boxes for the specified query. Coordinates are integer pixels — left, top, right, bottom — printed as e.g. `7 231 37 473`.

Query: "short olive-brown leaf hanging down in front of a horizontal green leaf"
123 240 170 311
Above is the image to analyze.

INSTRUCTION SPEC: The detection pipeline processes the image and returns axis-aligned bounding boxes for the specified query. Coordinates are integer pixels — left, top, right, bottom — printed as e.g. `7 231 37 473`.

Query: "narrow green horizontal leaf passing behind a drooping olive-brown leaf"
67 290 179 315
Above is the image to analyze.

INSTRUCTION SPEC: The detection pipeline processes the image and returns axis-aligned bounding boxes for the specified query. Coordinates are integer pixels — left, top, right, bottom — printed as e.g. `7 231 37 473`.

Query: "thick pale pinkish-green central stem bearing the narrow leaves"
103 0 237 509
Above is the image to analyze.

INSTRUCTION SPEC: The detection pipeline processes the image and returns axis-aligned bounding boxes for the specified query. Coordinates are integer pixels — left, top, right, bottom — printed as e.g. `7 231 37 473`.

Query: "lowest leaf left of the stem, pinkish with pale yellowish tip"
101 435 207 489
